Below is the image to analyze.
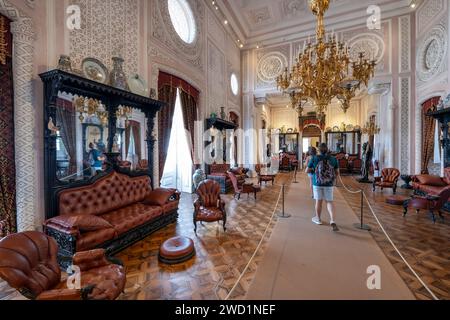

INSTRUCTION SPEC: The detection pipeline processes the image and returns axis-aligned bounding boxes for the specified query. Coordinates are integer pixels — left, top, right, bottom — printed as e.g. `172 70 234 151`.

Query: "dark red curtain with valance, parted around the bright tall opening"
158 72 200 180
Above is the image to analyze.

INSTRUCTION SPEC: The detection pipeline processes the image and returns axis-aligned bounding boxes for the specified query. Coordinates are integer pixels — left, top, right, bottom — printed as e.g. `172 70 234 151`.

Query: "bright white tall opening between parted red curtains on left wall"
161 89 193 193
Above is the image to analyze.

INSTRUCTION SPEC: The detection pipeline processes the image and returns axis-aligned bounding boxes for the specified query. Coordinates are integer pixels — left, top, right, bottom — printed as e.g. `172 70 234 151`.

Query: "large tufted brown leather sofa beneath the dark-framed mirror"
44 172 180 262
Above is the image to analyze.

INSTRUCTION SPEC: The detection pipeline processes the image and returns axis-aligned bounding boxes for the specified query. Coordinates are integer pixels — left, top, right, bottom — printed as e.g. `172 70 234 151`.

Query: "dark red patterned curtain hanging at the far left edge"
0 15 17 237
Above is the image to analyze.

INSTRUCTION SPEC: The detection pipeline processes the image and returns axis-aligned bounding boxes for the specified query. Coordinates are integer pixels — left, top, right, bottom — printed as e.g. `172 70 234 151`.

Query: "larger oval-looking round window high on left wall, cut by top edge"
168 0 197 44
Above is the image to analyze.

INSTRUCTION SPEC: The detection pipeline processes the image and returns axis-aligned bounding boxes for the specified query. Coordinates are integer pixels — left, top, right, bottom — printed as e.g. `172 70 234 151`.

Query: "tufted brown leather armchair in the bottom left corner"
0 231 126 300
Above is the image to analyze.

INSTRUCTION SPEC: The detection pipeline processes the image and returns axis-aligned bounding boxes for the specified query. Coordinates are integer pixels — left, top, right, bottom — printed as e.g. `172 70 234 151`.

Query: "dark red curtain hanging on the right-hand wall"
422 97 441 174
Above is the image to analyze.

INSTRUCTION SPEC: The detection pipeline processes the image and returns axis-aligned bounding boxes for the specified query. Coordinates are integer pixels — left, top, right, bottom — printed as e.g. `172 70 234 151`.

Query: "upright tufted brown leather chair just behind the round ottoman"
194 180 227 234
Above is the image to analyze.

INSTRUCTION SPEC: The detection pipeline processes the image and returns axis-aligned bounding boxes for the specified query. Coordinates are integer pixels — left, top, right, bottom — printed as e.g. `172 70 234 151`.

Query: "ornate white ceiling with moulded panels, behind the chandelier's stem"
221 0 418 45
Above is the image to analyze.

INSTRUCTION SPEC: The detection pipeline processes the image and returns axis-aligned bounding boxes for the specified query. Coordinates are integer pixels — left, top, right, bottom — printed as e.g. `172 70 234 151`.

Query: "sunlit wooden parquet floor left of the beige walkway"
0 173 292 300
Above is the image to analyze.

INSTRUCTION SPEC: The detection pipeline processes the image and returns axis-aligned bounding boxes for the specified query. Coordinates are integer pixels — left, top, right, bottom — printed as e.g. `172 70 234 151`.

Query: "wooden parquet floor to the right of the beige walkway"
340 177 450 300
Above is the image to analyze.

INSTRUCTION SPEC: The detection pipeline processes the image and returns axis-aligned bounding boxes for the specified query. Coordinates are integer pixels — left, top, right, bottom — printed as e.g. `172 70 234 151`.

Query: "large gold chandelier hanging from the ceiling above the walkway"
277 0 376 117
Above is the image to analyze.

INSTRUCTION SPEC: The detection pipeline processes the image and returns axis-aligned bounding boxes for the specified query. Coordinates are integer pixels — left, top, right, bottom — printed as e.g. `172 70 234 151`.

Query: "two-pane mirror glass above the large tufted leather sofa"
54 93 148 182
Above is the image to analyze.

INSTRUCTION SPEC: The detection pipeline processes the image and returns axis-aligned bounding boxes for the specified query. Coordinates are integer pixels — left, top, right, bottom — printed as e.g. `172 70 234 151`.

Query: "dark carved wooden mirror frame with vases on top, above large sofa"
40 70 165 219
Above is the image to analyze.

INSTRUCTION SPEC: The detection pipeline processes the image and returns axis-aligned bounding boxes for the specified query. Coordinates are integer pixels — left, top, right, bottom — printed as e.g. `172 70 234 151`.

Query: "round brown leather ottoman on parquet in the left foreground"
159 237 195 264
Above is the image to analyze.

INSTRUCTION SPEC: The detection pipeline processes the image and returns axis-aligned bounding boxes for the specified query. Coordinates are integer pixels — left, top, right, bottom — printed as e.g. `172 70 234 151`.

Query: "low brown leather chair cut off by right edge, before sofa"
403 189 450 223
